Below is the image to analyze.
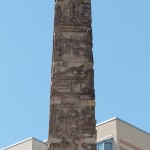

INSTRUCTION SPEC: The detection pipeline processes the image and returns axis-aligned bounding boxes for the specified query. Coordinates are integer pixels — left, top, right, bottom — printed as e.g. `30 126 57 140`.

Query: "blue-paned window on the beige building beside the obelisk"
97 139 113 150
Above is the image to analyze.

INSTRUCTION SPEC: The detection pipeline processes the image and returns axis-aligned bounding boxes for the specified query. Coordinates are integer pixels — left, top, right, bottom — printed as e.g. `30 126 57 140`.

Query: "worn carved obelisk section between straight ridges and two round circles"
54 40 93 62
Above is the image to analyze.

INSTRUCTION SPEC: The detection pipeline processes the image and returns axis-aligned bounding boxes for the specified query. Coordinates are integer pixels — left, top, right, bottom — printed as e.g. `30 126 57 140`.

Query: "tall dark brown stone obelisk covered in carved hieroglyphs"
48 0 96 150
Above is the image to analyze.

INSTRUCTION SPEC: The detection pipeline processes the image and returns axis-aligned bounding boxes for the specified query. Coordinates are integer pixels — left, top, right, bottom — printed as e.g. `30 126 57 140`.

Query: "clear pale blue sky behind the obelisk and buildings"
0 0 150 148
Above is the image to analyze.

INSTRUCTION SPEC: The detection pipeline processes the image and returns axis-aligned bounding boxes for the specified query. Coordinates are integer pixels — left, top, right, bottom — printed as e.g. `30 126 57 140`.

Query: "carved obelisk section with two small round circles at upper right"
53 66 94 99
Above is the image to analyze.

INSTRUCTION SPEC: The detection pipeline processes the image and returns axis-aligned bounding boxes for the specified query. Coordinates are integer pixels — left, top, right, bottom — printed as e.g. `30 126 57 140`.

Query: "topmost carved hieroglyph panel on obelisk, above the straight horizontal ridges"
55 0 91 26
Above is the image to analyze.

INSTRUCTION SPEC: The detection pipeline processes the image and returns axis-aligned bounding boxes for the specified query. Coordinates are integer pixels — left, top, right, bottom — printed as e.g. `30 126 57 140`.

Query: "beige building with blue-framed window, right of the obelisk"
96 118 150 150
